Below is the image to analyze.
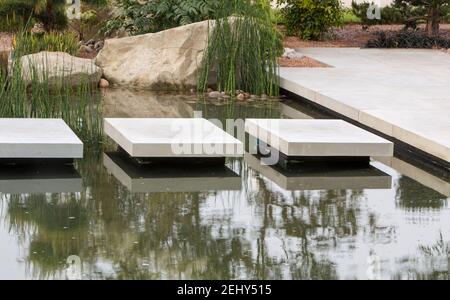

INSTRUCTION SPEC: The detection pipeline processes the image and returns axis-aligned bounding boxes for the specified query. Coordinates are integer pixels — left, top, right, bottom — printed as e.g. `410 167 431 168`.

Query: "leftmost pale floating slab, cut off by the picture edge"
0 119 83 163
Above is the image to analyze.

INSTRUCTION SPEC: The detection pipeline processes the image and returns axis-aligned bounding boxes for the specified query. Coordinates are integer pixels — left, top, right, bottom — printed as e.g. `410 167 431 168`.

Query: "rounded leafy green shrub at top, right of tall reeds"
278 0 343 40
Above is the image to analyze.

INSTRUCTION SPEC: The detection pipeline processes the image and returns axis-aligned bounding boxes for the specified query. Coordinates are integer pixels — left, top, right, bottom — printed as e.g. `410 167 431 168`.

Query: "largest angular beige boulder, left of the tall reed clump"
96 21 209 90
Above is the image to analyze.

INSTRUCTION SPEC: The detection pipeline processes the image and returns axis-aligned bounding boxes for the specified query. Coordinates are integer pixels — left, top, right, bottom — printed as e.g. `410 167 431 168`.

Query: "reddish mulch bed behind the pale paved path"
284 24 450 49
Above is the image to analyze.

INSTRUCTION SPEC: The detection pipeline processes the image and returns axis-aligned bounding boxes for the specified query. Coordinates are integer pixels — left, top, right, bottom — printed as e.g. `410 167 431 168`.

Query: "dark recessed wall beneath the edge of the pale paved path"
280 87 450 180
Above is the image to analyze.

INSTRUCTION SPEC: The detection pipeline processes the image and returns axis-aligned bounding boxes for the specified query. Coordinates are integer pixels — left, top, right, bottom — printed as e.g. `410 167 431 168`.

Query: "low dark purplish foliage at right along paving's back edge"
366 31 450 49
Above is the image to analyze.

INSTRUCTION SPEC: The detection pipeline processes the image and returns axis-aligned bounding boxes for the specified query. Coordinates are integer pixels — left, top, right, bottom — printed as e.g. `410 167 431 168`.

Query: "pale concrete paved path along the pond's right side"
280 48 450 163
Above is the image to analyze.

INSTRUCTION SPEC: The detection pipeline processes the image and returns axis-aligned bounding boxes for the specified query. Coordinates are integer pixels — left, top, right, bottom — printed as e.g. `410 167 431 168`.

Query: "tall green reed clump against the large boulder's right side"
198 0 282 95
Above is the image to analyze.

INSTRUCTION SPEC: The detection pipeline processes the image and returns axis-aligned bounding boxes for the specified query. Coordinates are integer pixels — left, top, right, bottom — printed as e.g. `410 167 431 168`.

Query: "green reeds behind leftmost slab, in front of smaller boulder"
0 30 103 146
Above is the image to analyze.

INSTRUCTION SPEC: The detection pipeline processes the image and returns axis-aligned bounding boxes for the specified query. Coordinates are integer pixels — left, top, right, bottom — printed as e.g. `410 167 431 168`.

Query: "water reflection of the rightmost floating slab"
244 153 392 191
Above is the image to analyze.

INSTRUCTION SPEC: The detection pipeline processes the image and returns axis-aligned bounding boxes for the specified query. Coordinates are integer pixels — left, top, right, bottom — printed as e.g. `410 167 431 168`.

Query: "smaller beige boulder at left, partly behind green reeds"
20 51 102 87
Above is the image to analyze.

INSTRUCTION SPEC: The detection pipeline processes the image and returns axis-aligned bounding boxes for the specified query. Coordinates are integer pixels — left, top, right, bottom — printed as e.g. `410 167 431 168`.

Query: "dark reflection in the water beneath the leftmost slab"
0 165 82 194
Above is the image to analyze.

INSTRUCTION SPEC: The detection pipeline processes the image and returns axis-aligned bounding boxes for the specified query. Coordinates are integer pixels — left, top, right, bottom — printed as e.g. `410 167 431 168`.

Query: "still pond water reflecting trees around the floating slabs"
0 89 450 279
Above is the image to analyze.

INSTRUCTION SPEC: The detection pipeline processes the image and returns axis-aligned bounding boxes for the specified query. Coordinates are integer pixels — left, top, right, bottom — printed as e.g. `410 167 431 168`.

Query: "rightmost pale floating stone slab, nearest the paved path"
245 119 394 163
